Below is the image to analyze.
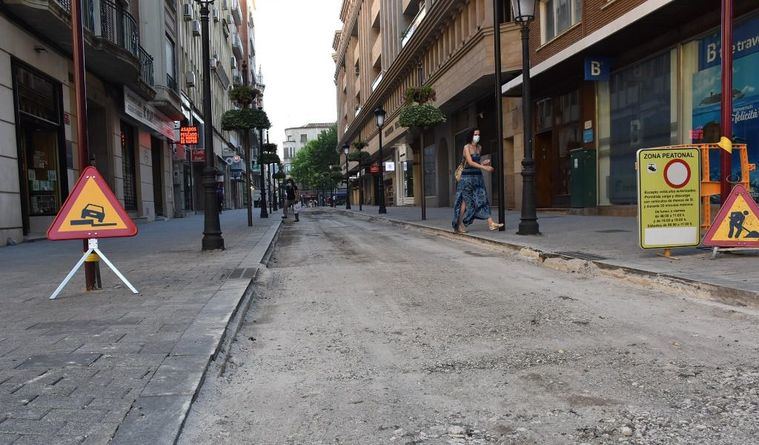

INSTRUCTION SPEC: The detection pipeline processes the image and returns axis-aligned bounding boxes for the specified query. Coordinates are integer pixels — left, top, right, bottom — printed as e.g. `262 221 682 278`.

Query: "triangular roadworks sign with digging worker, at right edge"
704 184 759 249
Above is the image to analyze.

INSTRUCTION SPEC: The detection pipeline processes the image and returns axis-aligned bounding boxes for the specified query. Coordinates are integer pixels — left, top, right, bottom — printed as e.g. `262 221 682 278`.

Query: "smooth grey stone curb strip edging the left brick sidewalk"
111 221 282 444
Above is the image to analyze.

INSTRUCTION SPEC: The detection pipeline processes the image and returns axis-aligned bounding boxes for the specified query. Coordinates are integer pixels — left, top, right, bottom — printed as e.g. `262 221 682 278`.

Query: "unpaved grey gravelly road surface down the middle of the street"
180 212 759 445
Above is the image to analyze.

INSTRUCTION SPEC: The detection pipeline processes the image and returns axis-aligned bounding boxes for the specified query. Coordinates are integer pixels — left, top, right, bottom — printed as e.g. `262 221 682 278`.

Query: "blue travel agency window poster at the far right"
692 17 759 198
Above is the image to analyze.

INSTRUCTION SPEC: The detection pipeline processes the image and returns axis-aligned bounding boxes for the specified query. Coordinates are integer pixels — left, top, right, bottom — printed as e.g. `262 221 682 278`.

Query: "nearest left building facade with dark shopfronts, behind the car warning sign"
0 0 176 245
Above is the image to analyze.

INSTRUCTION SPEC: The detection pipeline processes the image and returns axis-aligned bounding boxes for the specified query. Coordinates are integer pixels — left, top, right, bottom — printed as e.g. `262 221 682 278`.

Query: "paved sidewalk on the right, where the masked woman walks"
338 206 759 302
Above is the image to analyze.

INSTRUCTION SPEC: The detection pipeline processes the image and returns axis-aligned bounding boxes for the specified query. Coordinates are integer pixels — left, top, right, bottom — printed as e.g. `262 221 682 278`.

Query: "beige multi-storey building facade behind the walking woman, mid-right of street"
333 0 521 206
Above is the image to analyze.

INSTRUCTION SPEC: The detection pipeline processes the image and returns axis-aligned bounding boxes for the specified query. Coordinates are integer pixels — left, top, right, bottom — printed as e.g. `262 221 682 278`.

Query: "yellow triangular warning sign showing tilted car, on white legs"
47 167 137 240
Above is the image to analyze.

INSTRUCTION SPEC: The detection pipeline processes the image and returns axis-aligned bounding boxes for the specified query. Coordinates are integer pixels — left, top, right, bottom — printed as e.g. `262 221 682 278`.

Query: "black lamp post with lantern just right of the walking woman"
511 0 540 235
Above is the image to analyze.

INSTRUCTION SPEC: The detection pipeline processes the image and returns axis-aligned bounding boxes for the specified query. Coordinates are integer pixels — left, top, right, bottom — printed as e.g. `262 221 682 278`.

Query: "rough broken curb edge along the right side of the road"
332 207 759 307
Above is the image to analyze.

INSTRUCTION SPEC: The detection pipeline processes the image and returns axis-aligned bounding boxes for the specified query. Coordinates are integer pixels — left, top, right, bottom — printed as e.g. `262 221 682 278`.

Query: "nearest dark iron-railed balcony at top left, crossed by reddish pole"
3 0 155 99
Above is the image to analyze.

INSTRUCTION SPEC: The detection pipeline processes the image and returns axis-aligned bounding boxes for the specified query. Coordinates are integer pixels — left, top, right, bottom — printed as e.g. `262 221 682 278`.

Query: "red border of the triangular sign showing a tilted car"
47 166 137 241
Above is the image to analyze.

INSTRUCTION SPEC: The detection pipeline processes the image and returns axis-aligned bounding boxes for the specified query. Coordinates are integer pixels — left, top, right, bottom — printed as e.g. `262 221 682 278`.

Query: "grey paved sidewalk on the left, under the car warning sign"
0 210 281 444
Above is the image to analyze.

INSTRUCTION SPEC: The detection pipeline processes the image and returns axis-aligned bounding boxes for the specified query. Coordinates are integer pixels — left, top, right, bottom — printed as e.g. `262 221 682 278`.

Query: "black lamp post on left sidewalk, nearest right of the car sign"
195 0 224 250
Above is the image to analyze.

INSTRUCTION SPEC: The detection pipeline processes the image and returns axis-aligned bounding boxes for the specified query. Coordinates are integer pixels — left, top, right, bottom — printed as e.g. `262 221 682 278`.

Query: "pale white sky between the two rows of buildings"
255 0 342 154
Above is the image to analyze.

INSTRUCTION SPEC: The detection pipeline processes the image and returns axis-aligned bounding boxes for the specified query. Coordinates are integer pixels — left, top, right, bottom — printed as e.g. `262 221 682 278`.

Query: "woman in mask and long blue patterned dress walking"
451 129 503 233
